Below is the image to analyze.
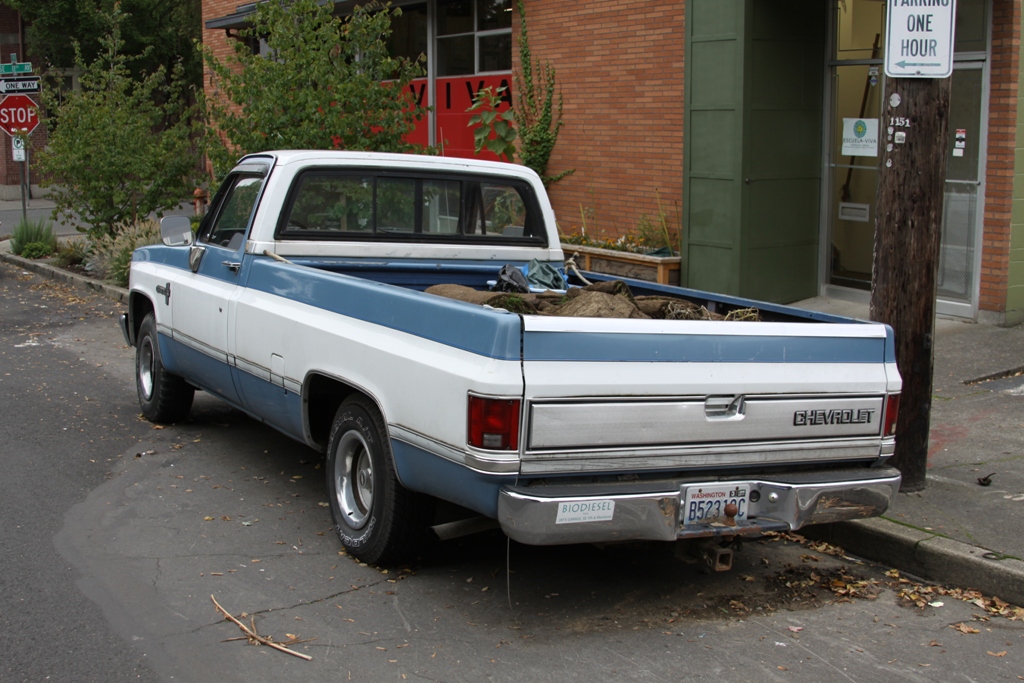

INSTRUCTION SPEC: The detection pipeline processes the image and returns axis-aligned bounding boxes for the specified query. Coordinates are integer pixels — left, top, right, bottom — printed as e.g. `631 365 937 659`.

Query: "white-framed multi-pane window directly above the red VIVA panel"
436 0 512 77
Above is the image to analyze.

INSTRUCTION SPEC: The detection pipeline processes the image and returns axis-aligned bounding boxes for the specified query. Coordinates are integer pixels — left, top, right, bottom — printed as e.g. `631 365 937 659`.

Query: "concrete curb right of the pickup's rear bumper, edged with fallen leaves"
799 517 1024 605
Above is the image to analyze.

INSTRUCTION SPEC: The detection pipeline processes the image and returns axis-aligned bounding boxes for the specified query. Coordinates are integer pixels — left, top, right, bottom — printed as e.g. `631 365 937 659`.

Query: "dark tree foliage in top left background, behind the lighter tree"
3 0 203 93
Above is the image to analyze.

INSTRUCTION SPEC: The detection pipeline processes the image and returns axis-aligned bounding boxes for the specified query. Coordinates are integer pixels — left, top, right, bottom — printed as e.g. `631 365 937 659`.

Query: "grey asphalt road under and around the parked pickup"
0 263 1024 683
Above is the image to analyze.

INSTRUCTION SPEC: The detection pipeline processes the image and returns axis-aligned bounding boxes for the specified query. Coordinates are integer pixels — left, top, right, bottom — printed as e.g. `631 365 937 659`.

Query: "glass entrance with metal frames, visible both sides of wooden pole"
822 0 990 317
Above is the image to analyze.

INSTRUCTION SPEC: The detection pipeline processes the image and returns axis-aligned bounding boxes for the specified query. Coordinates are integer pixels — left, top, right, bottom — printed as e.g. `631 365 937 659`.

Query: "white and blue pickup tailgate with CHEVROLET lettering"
521 315 900 475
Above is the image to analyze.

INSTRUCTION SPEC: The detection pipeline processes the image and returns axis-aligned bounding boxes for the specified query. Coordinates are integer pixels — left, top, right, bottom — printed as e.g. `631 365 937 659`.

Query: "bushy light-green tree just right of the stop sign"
39 5 199 237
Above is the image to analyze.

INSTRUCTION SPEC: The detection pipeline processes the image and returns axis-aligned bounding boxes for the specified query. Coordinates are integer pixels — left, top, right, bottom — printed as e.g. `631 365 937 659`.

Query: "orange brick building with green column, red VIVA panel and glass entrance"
128 0 1024 323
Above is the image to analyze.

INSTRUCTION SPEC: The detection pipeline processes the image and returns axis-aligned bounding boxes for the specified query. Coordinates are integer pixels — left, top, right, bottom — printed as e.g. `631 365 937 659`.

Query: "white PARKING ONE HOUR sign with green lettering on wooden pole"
886 0 956 78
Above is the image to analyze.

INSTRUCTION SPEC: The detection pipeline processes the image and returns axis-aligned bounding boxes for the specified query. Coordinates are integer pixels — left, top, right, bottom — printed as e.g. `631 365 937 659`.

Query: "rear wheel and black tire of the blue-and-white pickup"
327 396 433 564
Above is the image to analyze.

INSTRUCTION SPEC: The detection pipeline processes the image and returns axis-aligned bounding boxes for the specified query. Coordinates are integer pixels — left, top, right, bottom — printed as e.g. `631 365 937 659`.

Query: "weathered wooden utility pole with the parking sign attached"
870 0 956 492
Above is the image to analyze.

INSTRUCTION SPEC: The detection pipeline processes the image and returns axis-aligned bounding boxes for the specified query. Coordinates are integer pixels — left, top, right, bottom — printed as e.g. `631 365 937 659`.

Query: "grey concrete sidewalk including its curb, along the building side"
0 242 1024 605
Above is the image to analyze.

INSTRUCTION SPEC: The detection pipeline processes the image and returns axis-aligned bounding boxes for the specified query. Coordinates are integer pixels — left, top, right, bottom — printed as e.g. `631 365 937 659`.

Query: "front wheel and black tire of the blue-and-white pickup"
135 313 196 423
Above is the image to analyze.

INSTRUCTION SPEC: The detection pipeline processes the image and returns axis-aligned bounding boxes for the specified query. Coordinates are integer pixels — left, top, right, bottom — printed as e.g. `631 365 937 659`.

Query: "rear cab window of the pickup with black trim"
275 168 547 247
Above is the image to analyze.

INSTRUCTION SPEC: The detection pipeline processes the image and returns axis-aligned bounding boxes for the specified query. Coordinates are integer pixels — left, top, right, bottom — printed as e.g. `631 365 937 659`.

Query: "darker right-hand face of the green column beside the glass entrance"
740 0 827 303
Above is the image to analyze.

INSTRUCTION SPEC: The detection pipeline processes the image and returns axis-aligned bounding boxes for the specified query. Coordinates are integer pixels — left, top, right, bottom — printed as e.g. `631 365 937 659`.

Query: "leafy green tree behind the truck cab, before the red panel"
205 0 426 179
